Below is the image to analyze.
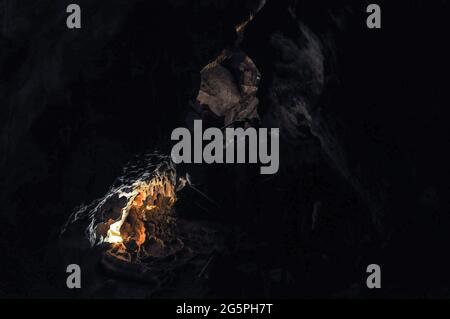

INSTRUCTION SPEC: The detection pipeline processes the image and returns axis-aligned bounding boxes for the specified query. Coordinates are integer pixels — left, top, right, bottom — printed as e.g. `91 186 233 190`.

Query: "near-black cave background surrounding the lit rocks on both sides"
0 0 450 297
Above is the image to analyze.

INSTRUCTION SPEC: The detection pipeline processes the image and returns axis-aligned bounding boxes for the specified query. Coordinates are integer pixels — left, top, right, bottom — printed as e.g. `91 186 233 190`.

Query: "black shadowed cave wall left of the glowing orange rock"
0 0 259 292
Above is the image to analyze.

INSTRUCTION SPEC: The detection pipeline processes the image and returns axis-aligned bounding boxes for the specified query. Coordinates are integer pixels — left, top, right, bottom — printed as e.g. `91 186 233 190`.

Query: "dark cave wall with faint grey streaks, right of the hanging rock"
243 1 449 296
